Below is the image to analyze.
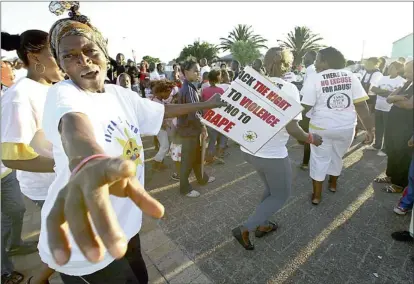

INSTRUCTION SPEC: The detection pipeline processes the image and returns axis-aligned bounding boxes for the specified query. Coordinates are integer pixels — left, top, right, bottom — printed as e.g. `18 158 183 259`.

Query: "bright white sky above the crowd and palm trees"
1 2 413 62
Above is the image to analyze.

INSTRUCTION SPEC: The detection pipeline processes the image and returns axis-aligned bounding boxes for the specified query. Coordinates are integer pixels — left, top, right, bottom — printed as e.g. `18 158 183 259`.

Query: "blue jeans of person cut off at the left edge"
1 171 26 274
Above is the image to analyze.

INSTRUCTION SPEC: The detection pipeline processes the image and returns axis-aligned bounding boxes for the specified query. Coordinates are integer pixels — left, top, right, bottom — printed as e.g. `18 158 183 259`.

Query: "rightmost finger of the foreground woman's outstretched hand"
125 178 165 218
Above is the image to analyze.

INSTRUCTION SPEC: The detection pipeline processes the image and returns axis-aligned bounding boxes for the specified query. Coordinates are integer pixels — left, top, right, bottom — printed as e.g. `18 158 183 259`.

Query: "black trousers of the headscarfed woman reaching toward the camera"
60 234 148 284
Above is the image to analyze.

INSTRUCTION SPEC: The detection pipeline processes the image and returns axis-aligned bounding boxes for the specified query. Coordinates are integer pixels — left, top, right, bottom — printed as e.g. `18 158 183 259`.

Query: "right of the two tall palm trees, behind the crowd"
278 26 325 66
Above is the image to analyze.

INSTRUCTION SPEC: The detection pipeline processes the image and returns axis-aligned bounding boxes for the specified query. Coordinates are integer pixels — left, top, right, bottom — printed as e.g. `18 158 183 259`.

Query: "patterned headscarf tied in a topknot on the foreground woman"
49 1 109 63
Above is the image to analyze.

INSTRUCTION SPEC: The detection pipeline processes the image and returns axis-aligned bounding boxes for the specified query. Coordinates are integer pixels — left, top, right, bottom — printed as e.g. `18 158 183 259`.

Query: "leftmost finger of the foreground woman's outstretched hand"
46 187 70 265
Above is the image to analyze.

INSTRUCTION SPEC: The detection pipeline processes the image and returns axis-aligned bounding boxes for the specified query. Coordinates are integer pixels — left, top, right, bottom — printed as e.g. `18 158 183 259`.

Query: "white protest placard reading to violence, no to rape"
201 67 303 154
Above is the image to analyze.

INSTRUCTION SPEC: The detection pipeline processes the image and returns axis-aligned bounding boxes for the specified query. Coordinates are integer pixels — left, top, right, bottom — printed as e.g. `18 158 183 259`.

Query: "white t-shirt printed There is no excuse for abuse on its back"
301 69 368 129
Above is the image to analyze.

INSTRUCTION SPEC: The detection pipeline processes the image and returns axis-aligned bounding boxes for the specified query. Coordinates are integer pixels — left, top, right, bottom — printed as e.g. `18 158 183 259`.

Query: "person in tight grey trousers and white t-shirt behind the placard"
232 47 324 250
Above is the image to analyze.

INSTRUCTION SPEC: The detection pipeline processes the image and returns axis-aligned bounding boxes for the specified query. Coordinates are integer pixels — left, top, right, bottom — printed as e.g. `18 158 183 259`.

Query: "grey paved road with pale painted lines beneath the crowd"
15 134 414 284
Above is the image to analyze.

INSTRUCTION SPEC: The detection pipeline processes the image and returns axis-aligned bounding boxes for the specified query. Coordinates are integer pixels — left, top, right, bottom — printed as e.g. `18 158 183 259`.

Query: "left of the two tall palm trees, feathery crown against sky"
220 24 267 51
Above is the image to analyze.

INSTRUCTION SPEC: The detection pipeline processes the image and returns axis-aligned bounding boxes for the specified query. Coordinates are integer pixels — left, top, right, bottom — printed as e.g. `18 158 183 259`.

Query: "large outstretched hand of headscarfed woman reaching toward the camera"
47 158 164 265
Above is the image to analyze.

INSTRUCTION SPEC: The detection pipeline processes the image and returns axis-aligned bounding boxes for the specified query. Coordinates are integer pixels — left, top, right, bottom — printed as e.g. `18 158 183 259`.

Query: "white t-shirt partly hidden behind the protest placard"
240 77 302 159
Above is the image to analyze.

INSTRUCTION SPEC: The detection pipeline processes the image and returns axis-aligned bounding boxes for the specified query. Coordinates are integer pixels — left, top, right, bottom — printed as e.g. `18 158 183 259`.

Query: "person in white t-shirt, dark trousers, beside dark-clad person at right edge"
368 61 406 156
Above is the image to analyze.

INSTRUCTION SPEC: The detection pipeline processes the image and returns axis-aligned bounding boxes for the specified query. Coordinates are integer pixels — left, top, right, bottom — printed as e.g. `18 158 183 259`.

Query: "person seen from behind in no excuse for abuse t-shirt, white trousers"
301 47 374 205
